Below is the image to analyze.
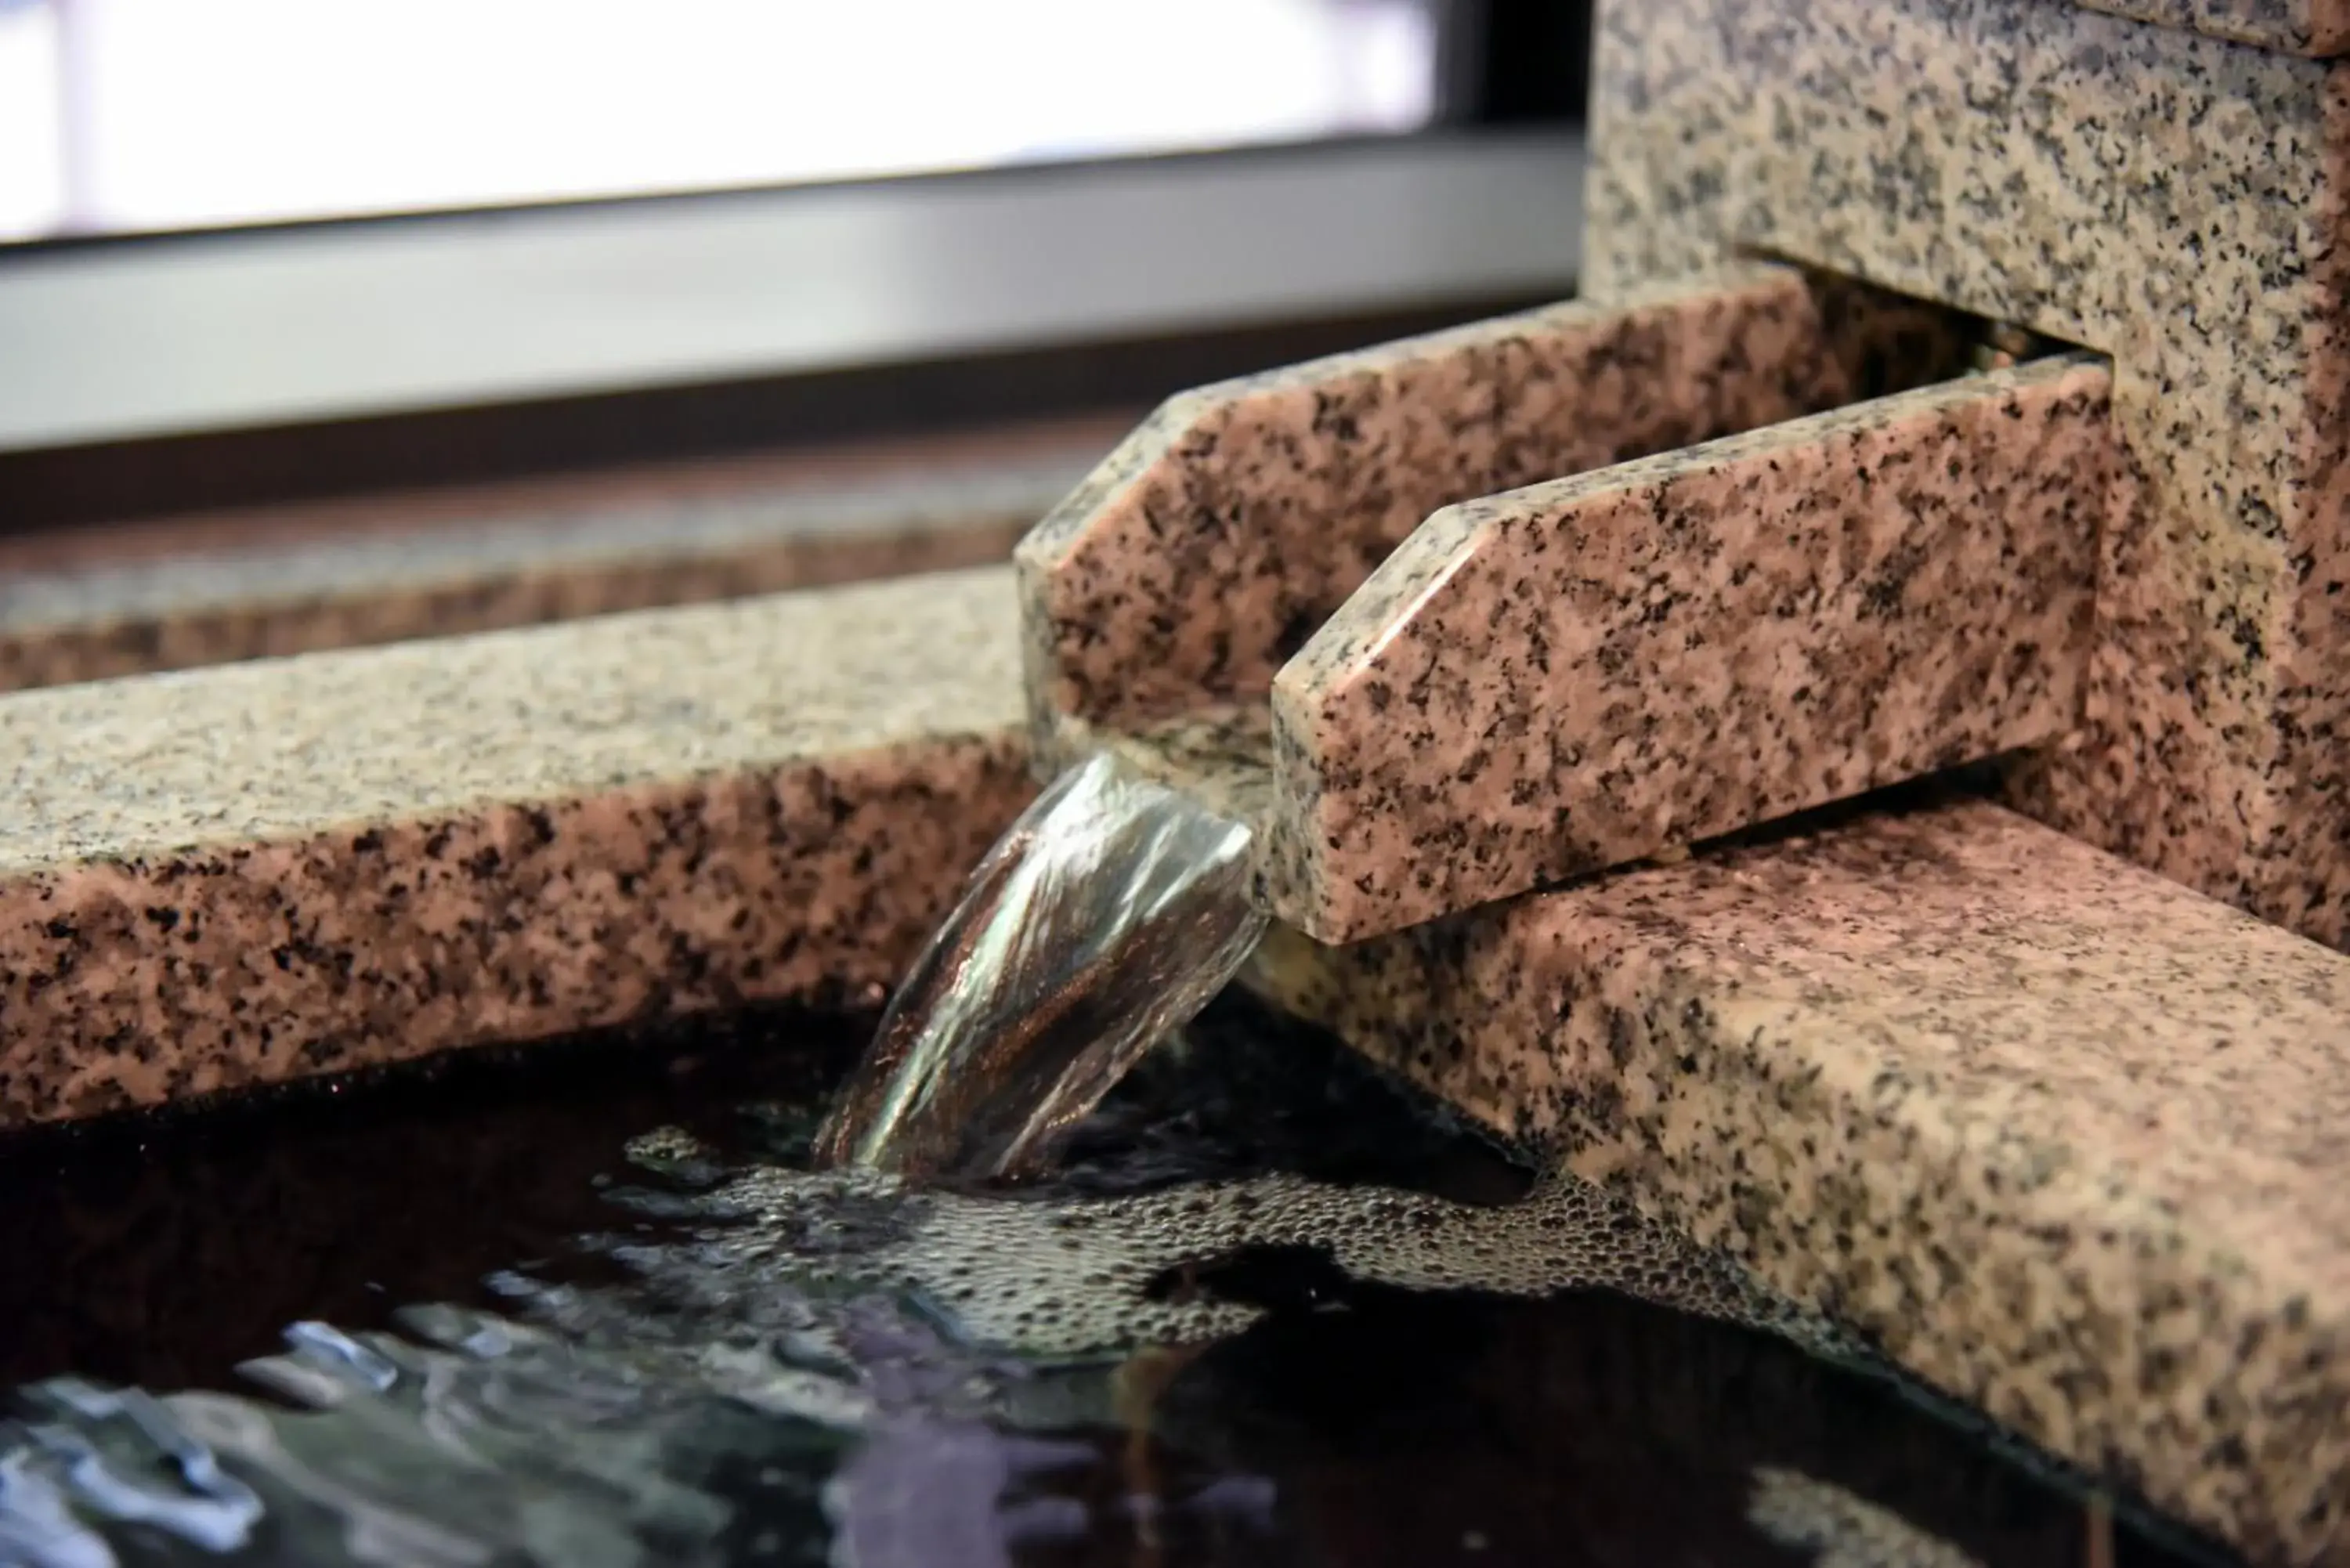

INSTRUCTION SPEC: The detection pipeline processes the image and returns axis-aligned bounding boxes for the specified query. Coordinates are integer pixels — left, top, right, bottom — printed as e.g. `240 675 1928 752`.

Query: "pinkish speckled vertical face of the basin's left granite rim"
0 731 1034 1129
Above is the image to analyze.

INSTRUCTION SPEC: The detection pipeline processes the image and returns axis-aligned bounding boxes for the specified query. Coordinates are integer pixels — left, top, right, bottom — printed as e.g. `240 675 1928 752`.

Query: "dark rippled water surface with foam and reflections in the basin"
0 1002 2218 1568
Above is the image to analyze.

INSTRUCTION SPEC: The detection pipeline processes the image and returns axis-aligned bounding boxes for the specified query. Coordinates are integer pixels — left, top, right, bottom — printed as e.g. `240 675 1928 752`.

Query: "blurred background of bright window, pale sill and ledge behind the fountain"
0 0 1591 686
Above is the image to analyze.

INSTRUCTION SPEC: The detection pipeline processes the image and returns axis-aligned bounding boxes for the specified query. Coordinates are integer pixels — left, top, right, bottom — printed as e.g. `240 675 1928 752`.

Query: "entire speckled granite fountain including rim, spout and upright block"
0 0 2350 1563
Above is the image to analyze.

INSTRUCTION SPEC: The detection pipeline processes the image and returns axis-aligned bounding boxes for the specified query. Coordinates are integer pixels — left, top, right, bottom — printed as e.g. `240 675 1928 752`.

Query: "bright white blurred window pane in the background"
0 0 1443 240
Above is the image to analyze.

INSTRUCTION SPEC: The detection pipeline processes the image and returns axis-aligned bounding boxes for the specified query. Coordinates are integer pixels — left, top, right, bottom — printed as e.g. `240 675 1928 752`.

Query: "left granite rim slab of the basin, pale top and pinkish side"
0 569 1032 1124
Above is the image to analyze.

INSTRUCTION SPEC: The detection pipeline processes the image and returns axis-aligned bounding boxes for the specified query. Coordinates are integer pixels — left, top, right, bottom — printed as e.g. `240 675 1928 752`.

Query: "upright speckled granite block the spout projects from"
1584 0 2350 945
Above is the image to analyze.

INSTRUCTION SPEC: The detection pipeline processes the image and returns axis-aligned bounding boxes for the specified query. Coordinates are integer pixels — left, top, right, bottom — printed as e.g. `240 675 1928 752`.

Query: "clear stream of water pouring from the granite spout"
815 754 1264 1178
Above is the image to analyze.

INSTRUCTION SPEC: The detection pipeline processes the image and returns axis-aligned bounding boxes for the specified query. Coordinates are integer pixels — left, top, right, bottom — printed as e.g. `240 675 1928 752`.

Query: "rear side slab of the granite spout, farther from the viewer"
1018 266 1962 728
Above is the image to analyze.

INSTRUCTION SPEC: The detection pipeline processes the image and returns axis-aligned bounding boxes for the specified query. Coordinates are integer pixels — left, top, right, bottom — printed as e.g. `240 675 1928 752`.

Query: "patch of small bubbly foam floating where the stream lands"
663 1169 1856 1359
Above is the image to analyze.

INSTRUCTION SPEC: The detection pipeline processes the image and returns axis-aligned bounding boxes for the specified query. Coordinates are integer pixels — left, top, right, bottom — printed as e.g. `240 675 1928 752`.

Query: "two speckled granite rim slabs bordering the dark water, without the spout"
0 531 2350 1552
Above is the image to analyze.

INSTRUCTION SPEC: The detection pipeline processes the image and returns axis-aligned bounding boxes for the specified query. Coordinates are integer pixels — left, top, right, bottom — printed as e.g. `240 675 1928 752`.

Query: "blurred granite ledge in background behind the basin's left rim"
0 453 1081 691
